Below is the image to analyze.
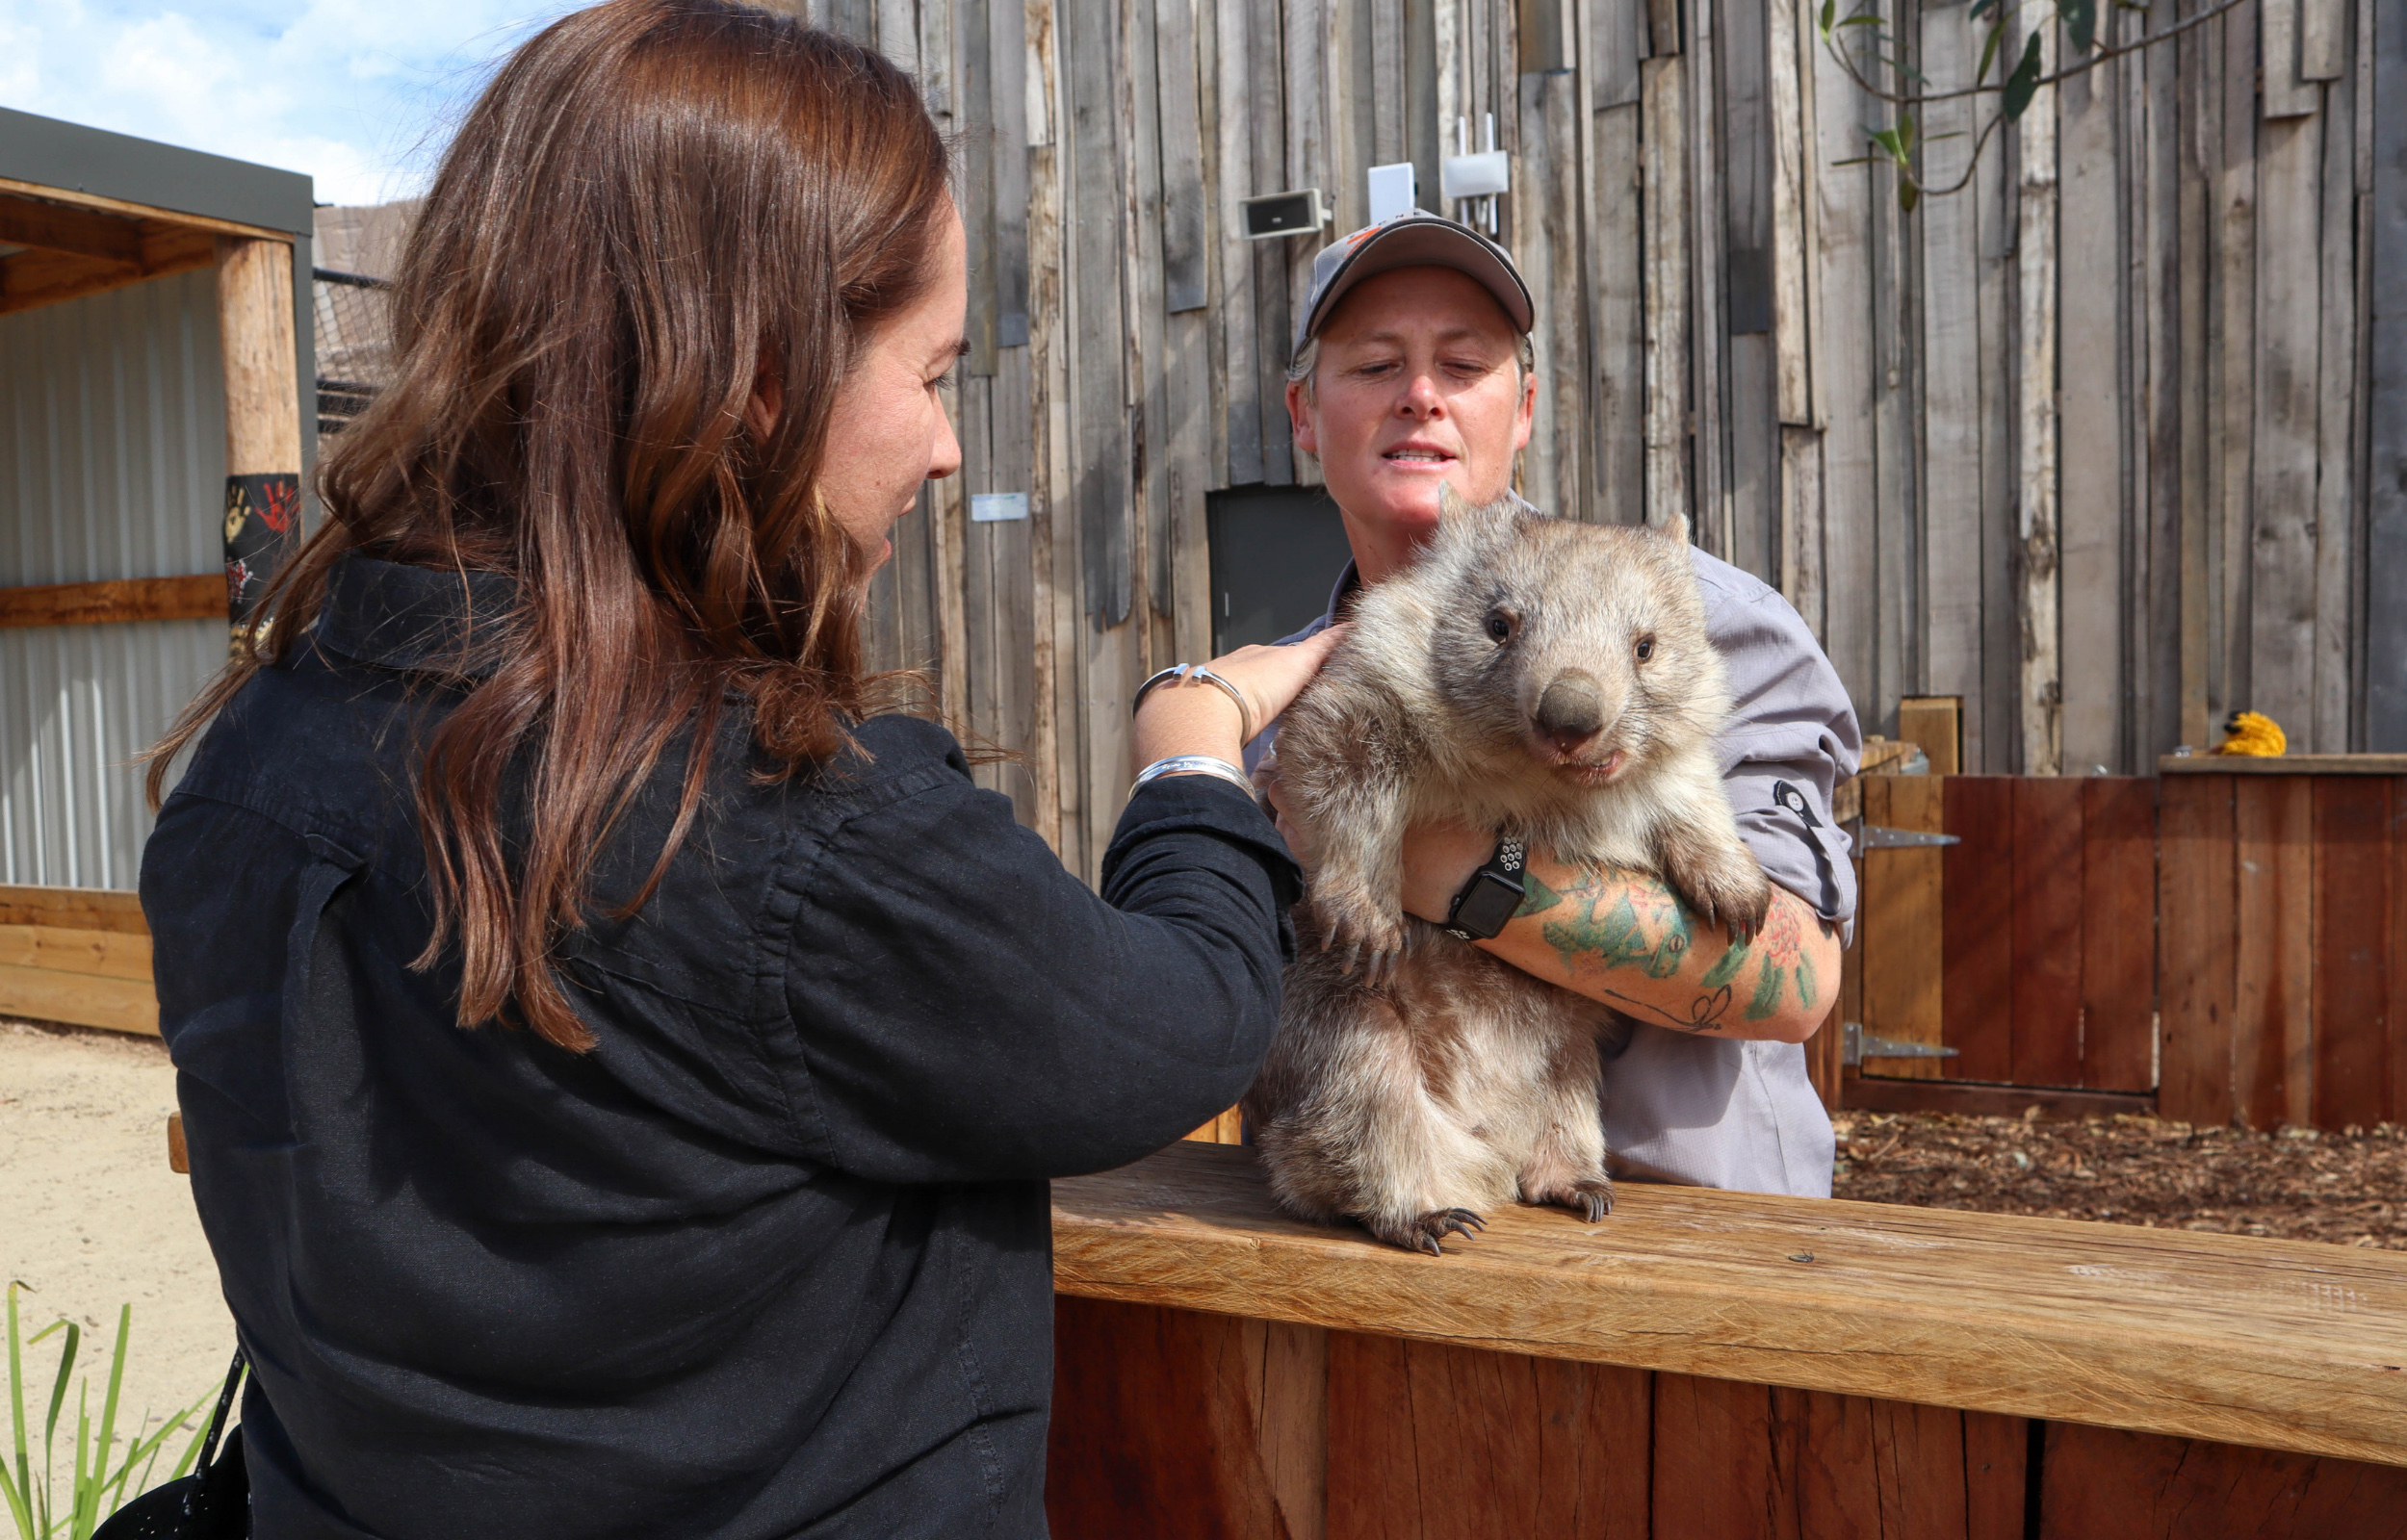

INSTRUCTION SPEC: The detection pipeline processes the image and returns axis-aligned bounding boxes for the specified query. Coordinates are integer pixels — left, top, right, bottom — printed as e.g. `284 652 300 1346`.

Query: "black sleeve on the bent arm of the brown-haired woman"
788 778 1303 1182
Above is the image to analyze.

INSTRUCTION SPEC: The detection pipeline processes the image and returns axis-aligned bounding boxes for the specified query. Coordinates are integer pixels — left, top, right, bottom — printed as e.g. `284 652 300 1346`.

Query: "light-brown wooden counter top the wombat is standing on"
1052 1143 2407 1466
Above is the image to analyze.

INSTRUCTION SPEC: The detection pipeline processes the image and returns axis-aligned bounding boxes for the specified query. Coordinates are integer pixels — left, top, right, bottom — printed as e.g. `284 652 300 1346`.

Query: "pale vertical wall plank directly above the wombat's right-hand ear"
1640 56 1695 525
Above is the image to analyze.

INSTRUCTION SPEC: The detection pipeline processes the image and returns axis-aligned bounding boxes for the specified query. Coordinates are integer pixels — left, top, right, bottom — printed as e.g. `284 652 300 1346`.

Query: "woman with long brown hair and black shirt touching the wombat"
142 0 1327 1540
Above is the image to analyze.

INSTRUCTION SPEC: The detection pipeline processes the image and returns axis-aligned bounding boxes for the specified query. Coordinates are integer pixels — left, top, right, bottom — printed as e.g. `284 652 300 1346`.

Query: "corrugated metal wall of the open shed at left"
0 270 226 888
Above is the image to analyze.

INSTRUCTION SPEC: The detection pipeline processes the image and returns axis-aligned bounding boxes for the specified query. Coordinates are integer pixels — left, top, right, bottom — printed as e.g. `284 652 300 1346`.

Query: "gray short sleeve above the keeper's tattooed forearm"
1707 568 1863 934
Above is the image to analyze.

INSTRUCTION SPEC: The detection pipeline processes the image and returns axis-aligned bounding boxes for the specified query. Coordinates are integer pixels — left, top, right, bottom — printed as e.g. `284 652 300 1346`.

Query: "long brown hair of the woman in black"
149 0 948 1049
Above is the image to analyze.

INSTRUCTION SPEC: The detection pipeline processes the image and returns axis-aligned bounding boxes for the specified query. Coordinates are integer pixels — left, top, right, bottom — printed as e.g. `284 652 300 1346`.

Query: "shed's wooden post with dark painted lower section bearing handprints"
217 236 301 626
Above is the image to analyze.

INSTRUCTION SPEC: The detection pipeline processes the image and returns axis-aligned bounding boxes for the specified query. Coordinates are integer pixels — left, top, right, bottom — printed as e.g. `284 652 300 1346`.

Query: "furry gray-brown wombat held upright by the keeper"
1245 491 1772 1254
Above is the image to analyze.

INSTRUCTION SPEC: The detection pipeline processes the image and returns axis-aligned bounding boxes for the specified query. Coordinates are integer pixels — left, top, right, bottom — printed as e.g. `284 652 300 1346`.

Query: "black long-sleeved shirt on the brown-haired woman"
142 556 1298 1540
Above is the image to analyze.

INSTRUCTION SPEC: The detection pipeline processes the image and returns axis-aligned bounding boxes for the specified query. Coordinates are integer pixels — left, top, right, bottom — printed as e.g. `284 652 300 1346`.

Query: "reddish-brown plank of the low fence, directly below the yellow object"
2232 775 2316 1129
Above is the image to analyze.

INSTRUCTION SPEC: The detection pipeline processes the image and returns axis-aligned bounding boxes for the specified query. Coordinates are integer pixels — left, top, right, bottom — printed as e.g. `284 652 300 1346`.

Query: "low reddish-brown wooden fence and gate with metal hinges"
1815 756 2407 1129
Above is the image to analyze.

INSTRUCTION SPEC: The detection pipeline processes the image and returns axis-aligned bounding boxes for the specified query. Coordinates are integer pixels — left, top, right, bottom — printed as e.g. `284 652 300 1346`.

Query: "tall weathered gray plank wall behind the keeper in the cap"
778 0 2407 866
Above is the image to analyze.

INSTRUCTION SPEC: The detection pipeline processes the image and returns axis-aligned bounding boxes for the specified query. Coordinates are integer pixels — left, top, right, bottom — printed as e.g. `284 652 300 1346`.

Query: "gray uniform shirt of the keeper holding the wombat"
1245 552 1863 1198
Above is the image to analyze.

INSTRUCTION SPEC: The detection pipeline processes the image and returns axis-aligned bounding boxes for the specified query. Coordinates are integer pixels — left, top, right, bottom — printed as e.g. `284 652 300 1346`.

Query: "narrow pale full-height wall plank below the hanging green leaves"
2015 19 2063 770
